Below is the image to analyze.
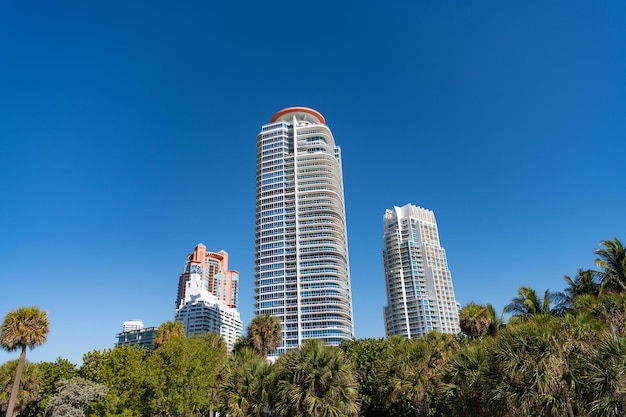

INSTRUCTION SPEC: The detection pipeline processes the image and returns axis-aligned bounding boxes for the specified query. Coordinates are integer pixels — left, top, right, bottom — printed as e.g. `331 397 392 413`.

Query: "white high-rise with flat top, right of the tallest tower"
383 204 460 338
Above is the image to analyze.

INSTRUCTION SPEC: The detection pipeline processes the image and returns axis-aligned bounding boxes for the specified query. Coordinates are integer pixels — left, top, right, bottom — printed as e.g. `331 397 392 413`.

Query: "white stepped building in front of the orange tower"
176 270 243 351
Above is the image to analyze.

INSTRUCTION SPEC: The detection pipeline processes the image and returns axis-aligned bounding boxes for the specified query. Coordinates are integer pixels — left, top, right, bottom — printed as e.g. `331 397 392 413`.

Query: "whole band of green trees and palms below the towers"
0 238 626 417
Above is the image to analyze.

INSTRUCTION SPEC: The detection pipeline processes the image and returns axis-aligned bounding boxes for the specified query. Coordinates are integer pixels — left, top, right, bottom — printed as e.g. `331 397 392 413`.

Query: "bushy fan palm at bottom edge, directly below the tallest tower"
270 339 360 417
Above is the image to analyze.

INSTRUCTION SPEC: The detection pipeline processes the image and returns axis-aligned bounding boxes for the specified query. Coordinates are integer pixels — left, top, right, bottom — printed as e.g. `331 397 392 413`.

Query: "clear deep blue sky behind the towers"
0 0 626 364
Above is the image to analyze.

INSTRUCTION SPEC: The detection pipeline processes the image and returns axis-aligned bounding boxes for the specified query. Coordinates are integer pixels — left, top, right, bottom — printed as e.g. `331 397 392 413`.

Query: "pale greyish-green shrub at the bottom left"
46 377 107 417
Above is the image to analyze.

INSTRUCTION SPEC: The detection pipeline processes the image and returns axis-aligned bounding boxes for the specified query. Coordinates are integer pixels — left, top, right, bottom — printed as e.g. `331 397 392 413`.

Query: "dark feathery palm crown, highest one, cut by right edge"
595 237 626 292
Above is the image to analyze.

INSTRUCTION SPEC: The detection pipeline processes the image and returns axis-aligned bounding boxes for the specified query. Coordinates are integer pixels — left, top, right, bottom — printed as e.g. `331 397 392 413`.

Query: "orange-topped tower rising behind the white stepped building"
176 243 239 308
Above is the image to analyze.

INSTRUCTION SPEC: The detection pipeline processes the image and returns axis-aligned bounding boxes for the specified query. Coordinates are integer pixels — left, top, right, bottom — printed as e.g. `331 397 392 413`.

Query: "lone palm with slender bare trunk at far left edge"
0 307 50 417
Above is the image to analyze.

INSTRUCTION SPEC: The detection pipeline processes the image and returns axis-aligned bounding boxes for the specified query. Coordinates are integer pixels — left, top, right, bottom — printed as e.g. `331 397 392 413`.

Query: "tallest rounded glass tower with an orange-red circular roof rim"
254 107 354 353
